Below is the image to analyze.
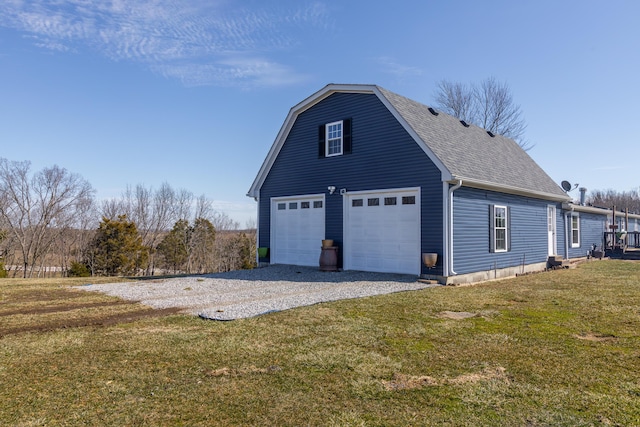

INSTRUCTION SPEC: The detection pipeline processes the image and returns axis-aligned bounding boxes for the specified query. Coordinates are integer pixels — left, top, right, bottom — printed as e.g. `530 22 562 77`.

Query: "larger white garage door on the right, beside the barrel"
344 189 420 275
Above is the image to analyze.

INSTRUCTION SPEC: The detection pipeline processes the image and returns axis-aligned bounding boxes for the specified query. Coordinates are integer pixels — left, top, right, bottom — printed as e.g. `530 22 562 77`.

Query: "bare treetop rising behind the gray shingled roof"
435 77 533 150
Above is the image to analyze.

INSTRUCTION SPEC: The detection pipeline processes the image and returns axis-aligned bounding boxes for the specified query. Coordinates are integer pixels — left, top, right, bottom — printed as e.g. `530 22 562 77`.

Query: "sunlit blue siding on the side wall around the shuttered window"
453 187 562 274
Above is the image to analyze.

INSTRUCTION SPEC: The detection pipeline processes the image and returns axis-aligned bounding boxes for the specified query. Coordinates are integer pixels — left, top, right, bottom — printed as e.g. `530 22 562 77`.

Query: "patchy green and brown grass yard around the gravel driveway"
0 261 640 426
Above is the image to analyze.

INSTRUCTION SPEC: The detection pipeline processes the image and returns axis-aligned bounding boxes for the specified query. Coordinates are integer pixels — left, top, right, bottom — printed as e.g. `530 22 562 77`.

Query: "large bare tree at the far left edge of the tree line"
0 159 93 277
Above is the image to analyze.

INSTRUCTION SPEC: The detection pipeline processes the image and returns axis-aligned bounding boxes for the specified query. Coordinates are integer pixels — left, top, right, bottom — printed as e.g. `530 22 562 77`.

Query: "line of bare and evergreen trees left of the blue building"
0 158 256 277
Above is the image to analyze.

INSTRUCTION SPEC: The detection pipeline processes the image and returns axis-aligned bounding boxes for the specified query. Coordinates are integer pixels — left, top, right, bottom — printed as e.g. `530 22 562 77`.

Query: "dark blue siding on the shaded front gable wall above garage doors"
259 93 442 274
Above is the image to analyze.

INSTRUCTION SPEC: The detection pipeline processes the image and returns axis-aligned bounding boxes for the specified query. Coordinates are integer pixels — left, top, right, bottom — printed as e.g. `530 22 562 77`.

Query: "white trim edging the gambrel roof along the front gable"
247 83 452 198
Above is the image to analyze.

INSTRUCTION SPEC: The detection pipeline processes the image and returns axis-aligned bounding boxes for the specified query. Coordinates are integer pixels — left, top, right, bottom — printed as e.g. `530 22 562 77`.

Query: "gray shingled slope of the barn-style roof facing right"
377 86 568 199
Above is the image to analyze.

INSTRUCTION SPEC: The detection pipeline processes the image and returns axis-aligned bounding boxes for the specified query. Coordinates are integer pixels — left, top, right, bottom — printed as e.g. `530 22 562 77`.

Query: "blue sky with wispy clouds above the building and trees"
0 0 640 225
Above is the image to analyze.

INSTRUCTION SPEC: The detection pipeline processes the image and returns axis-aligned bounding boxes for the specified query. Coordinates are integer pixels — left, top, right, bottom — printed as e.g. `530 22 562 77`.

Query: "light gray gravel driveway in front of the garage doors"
80 265 437 320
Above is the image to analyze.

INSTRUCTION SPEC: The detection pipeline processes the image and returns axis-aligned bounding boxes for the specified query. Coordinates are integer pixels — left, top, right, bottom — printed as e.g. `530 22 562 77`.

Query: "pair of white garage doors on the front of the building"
271 188 421 275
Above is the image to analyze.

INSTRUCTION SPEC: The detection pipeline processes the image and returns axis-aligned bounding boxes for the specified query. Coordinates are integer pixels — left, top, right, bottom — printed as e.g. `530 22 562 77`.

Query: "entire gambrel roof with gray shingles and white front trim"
247 84 570 201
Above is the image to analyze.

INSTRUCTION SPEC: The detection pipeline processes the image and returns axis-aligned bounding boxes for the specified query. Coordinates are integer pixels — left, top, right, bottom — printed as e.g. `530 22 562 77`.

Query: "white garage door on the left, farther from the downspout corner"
271 195 325 266
